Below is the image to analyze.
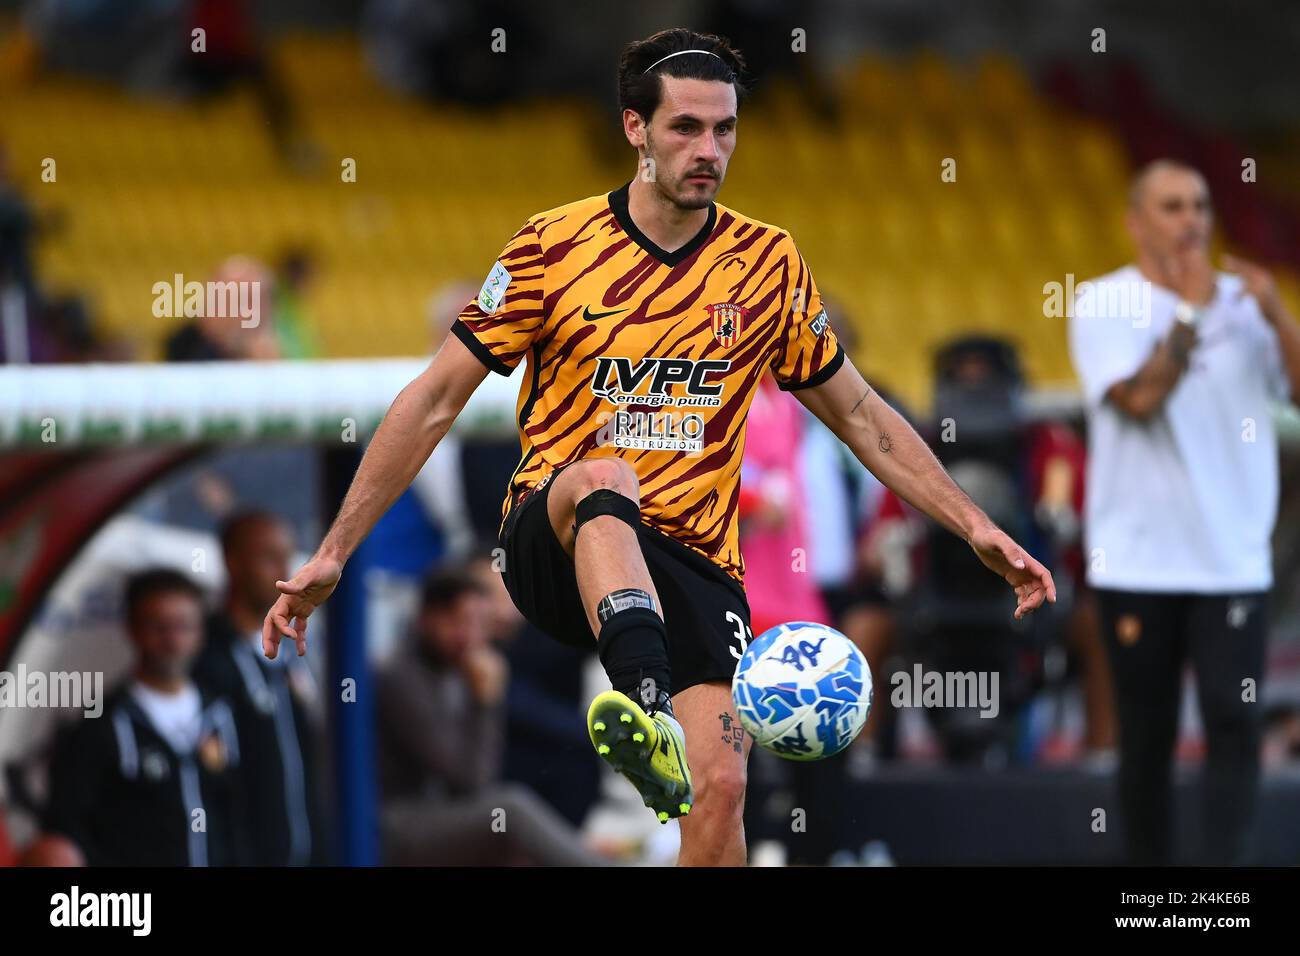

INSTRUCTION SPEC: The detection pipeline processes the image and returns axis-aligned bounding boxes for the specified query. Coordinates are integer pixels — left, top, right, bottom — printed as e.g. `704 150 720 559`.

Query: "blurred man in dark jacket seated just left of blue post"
194 511 329 866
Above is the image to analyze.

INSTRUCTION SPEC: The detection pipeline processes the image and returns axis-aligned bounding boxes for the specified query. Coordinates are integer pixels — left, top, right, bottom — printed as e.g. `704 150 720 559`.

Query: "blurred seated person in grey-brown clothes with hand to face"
378 567 603 866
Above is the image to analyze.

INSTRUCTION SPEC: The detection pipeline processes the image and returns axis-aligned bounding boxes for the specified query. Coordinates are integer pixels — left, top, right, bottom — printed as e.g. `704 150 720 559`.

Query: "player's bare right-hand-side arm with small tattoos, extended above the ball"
794 360 1056 618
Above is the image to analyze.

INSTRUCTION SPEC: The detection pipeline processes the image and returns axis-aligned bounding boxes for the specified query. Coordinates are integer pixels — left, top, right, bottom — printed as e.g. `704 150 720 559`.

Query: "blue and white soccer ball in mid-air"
732 620 871 760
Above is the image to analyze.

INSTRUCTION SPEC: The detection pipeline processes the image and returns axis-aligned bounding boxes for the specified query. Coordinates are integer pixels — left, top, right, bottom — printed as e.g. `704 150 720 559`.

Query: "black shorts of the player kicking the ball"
501 472 754 693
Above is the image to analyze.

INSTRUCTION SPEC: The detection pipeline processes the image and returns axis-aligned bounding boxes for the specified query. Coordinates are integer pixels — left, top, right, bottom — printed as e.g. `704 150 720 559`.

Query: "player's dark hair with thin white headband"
619 27 746 122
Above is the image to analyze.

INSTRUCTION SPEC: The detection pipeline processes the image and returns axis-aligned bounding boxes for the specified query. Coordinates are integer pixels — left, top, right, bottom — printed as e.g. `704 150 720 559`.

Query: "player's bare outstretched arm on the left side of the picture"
261 336 488 658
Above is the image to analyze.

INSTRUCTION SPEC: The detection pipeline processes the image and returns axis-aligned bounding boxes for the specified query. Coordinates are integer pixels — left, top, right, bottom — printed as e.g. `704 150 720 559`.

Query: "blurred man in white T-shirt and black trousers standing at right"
1070 160 1300 864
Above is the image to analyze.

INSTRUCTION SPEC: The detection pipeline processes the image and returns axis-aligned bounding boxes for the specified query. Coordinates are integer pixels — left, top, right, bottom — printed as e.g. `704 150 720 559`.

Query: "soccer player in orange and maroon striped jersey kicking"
264 29 1056 865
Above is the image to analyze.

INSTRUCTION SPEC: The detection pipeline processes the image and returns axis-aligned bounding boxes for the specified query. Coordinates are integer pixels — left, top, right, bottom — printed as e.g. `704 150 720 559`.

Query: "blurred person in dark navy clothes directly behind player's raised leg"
469 541 601 826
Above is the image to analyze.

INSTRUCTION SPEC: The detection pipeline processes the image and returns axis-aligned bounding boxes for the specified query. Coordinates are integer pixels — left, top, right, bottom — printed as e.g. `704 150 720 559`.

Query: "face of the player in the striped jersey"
645 77 736 209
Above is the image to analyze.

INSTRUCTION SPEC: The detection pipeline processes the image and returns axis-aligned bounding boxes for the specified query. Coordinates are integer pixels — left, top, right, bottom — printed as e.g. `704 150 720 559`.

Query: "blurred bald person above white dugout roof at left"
164 256 281 362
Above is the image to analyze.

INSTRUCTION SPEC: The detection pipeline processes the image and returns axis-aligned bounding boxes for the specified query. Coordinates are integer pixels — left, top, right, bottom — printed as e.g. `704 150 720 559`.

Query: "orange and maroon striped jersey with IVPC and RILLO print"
452 179 844 581
